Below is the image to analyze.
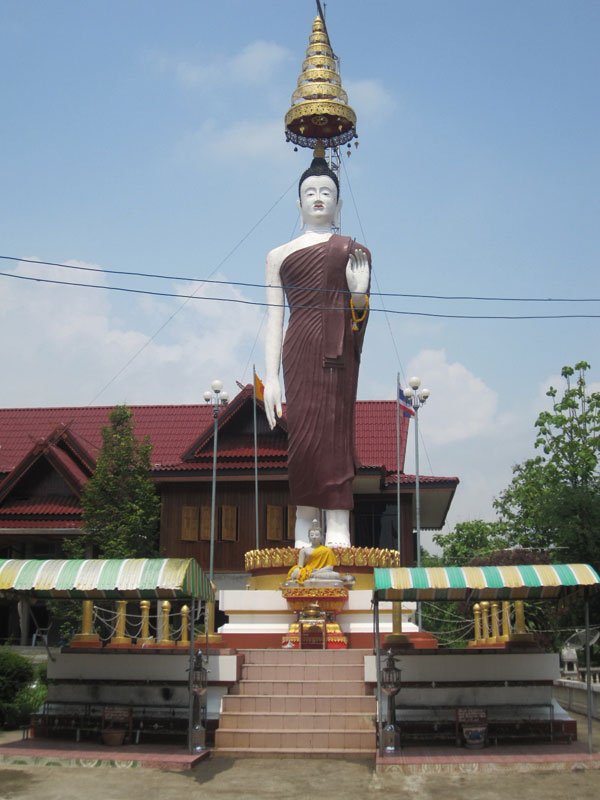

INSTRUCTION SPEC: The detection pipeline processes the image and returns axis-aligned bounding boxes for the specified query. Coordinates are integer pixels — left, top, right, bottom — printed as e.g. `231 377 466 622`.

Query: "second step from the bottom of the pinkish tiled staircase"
219 711 375 731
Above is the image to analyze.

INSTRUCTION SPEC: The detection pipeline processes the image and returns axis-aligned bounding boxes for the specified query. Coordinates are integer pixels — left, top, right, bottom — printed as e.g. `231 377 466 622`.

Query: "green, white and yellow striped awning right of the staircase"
374 564 600 600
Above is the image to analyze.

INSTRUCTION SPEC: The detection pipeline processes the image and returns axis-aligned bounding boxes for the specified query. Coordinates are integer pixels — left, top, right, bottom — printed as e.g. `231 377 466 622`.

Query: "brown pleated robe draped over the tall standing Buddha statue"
281 235 371 509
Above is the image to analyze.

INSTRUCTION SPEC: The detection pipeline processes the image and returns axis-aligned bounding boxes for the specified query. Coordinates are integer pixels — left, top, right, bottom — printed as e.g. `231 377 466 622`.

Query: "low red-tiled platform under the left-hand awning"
0 733 210 770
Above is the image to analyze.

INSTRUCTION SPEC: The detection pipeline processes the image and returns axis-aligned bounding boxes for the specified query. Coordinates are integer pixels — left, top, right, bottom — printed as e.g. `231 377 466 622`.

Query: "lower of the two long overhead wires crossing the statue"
0 272 600 318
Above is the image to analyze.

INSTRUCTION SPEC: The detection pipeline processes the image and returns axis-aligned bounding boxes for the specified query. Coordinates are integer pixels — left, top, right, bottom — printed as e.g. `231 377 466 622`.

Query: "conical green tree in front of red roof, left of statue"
71 406 160 558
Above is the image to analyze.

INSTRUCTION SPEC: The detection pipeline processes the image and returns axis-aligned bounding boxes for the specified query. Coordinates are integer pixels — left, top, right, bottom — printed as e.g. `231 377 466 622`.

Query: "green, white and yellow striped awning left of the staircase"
0 558 214 600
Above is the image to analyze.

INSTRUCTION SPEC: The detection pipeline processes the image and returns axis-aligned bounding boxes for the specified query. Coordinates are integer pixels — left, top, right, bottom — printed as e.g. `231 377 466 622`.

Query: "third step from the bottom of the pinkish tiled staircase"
221 693 377 715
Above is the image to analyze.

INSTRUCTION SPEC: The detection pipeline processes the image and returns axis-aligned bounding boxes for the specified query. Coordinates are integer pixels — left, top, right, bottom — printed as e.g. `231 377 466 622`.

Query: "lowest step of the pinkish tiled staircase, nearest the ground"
215 728 376 752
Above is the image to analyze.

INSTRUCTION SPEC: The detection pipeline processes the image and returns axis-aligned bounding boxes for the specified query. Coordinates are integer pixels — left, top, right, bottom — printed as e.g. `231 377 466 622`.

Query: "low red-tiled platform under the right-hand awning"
375 741 600 774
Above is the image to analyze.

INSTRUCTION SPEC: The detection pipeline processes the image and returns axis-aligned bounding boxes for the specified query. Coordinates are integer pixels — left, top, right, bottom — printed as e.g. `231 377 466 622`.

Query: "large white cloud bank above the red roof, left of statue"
0 262 261 406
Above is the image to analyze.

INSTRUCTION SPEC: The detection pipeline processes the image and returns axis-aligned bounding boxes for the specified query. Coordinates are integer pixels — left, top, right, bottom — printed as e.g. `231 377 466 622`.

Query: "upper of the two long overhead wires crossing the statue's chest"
0 255 600 303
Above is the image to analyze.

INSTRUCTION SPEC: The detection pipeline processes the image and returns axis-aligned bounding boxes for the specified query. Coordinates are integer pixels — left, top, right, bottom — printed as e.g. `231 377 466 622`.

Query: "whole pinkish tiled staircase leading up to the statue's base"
213 650 376 758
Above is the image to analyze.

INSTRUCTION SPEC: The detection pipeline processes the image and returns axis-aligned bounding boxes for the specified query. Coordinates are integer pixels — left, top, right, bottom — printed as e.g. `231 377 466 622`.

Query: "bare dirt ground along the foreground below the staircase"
0 717 600 800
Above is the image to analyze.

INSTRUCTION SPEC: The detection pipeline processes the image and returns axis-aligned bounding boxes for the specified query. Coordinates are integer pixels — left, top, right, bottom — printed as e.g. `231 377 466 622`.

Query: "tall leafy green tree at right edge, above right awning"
495 361 600 568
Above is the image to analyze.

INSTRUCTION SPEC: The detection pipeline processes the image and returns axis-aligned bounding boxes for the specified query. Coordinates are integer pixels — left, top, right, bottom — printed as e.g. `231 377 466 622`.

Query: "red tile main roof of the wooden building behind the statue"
0 386 458 483
